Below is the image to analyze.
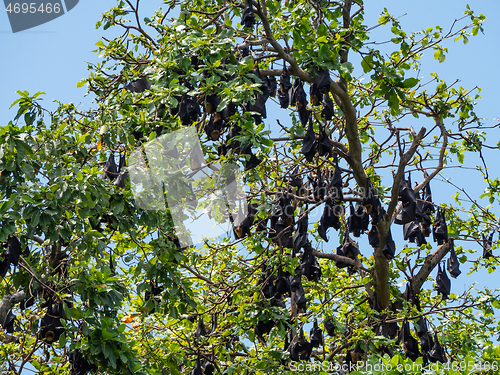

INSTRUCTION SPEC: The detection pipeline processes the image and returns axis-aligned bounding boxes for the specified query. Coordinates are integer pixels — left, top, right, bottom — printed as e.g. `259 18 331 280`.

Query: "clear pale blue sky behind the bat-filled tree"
0 0 500 340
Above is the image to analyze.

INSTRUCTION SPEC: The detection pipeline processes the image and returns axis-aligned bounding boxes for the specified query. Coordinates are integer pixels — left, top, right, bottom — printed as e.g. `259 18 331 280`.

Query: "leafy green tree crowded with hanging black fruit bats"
0 0 500 374
